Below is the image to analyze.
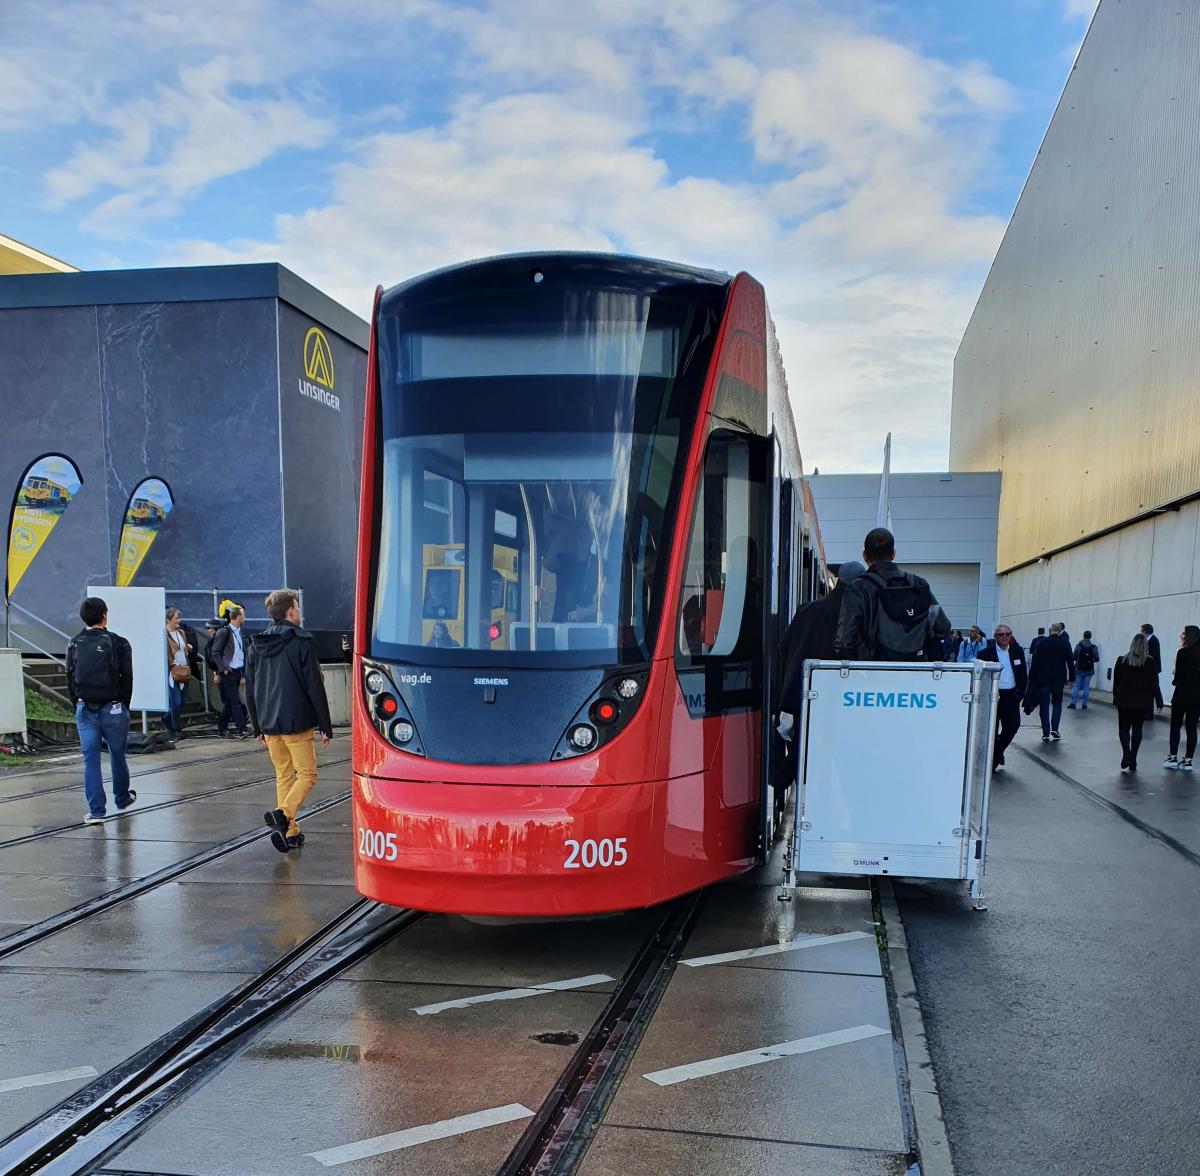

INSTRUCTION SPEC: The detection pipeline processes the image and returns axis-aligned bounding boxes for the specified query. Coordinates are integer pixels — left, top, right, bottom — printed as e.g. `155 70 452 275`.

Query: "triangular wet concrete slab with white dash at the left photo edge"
0 970 255 1138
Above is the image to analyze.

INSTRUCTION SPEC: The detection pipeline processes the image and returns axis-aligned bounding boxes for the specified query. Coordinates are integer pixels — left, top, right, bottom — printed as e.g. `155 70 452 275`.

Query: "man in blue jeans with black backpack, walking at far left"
67 596 138 824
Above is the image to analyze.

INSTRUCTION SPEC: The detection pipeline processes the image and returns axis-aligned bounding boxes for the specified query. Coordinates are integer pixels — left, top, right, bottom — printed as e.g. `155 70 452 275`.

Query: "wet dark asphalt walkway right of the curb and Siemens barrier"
896 704 1200 1176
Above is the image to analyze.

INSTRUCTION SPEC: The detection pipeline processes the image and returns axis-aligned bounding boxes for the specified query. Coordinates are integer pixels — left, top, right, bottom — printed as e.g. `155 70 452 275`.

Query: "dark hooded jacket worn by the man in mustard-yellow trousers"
246 620 334 736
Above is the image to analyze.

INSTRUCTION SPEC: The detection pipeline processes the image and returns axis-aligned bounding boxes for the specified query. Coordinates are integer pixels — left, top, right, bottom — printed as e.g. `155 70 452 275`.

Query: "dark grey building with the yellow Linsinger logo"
0 264 367 649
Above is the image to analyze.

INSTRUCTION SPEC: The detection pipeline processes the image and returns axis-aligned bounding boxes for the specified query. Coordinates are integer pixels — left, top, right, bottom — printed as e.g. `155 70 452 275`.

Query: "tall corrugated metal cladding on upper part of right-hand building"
950 0 1200 571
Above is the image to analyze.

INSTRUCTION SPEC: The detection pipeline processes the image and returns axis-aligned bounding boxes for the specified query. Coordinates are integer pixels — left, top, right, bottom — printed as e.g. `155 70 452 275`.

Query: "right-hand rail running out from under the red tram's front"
497 892 704 1176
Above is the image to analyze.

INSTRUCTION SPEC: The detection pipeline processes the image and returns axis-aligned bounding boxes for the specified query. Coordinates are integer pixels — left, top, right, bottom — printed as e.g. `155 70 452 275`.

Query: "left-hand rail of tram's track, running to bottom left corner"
0 899 425 1176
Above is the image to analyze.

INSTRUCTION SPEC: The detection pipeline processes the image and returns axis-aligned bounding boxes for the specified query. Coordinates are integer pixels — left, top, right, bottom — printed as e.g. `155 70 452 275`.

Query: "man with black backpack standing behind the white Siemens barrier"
834 527 950 661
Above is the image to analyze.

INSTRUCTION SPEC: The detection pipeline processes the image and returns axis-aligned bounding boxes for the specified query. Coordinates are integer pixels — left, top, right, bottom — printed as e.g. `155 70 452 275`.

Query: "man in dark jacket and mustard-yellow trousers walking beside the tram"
246 588 334 853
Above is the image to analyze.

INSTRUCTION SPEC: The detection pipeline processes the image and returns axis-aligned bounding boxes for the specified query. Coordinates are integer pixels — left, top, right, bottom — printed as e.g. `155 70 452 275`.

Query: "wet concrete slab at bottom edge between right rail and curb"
578 1124 907 1176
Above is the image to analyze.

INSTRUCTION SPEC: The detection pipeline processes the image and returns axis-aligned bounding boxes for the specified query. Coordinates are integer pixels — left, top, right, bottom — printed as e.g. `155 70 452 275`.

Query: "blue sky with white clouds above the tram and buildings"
0 0 1103 473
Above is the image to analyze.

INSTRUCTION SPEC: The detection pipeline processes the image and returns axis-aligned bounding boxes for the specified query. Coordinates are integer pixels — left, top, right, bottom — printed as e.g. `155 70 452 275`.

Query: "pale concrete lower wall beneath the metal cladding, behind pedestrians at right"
1001 503 1200 701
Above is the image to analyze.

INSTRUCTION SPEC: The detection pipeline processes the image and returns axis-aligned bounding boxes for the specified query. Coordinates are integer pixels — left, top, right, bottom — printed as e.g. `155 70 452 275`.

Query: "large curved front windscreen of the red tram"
370 256 728 668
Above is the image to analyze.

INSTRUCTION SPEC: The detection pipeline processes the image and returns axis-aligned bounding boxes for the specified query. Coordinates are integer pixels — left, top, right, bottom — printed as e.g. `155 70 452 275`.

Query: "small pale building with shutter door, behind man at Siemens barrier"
809 474 1003 643
